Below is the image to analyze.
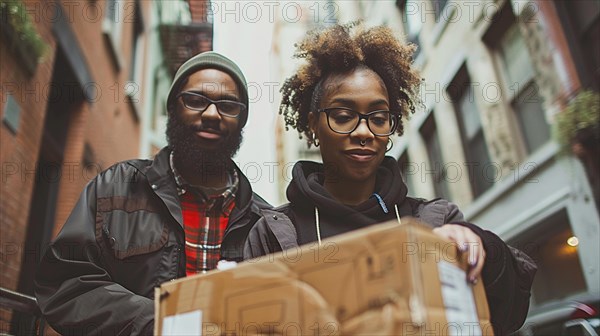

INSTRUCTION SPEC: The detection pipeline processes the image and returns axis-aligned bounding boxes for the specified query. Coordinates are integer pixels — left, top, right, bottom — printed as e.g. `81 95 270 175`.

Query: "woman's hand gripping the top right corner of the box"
433 224 485 284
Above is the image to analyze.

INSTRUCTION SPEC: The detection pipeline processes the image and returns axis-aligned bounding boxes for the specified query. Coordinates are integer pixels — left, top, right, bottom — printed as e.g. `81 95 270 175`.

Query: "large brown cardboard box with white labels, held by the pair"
155 219 493 335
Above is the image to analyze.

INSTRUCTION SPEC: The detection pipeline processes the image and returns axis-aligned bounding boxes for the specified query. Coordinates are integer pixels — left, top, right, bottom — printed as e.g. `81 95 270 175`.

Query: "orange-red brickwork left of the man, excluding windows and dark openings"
0 0 151 333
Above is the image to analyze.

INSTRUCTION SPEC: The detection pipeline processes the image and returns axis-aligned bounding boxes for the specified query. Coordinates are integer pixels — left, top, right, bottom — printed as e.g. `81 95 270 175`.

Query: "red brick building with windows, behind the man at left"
0 0 190 334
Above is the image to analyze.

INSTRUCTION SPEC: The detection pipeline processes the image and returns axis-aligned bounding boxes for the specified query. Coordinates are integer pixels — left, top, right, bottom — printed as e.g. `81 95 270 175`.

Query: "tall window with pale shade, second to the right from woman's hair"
447 65 495 198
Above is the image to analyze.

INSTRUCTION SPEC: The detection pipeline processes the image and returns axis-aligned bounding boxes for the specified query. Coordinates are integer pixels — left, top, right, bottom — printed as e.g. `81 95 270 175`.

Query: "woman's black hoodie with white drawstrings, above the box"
278 157 463 245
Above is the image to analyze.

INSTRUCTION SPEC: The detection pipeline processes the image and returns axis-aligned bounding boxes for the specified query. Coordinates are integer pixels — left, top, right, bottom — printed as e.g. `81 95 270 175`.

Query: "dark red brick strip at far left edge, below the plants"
0 0 55 318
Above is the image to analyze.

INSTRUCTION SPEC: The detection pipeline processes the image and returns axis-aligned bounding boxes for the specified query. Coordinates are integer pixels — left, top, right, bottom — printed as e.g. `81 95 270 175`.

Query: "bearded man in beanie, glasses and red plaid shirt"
35 52 270 335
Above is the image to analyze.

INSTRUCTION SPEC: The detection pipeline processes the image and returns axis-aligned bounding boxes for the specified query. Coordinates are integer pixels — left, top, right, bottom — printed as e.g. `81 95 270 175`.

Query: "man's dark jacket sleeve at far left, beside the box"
35 180 154 335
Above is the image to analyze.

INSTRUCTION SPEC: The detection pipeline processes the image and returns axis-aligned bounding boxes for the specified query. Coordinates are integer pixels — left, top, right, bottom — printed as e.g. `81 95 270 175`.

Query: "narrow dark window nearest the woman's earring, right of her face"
421 112 450 199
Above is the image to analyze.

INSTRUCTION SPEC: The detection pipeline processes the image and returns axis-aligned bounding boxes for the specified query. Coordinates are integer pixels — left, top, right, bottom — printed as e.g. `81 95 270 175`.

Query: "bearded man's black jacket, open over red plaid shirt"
35 148 270 335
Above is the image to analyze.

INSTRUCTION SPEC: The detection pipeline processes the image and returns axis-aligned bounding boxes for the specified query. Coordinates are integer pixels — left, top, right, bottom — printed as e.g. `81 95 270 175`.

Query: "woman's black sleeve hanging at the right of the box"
456 222 537 335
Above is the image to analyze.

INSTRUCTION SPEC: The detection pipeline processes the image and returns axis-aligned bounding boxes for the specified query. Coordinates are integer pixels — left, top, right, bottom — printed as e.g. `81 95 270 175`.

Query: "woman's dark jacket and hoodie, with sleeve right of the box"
244 157 537 335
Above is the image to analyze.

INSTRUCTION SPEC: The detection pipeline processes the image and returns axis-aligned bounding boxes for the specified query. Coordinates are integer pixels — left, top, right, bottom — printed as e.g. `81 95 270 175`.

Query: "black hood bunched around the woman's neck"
287 156 407 231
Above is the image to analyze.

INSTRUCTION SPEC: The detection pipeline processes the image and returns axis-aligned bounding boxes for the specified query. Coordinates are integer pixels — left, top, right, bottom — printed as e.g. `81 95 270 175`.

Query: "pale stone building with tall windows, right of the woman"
276 0 600 334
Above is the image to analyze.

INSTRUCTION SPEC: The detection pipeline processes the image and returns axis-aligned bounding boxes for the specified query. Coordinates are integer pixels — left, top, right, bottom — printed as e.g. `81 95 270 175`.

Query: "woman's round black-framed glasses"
317 107 398 136
